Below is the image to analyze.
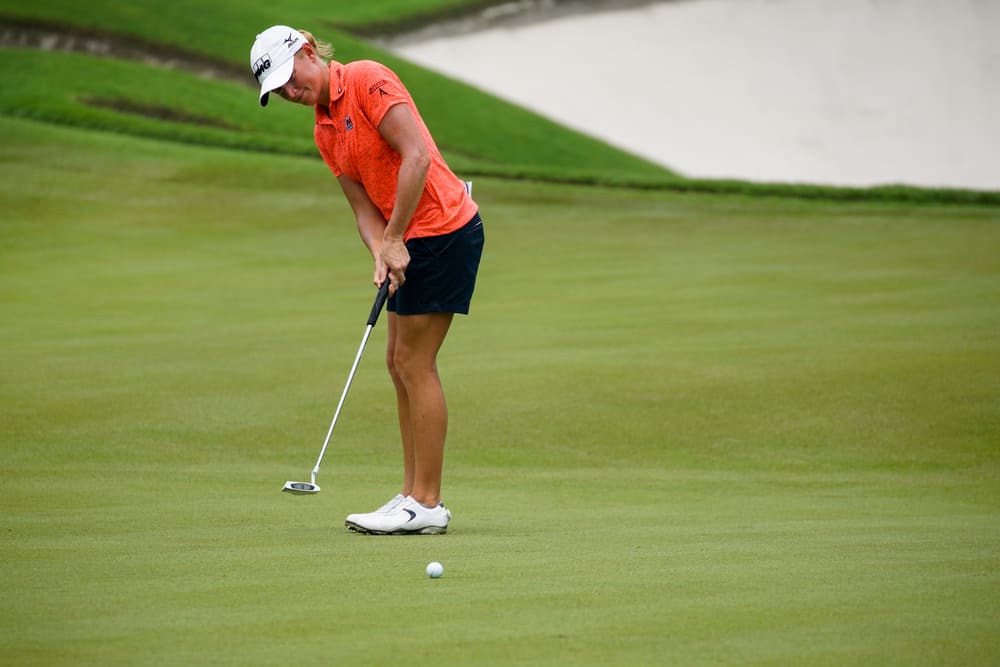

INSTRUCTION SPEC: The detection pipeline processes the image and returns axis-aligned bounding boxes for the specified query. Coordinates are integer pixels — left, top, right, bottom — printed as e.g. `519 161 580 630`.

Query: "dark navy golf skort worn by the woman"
386 213 486 315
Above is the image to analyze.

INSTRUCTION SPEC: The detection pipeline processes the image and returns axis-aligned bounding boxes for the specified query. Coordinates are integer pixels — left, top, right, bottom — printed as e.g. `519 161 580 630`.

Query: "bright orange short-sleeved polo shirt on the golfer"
314 60 477 240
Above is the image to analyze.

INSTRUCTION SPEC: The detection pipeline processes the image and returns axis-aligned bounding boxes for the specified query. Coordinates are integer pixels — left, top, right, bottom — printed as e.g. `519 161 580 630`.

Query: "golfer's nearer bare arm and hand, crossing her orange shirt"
378 104 431 287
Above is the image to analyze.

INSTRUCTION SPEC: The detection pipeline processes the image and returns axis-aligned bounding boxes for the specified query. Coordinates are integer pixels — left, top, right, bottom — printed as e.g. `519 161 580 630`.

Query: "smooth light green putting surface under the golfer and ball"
0 118 1000 665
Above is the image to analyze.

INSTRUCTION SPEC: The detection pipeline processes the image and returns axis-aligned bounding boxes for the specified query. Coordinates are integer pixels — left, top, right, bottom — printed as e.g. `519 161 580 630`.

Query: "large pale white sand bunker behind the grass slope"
387 0 1000 189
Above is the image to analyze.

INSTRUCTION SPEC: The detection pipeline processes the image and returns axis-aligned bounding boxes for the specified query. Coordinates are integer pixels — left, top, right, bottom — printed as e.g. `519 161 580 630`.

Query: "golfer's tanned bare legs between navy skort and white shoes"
386 313 453 506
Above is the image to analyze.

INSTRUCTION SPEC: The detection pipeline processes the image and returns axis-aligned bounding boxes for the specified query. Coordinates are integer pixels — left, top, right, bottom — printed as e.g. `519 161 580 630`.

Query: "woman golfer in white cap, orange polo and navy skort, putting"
250 26 484 535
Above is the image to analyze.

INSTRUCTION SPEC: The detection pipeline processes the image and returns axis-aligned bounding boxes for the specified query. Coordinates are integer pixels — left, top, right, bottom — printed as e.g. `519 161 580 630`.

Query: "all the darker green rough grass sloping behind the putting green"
0 0 1000 205
